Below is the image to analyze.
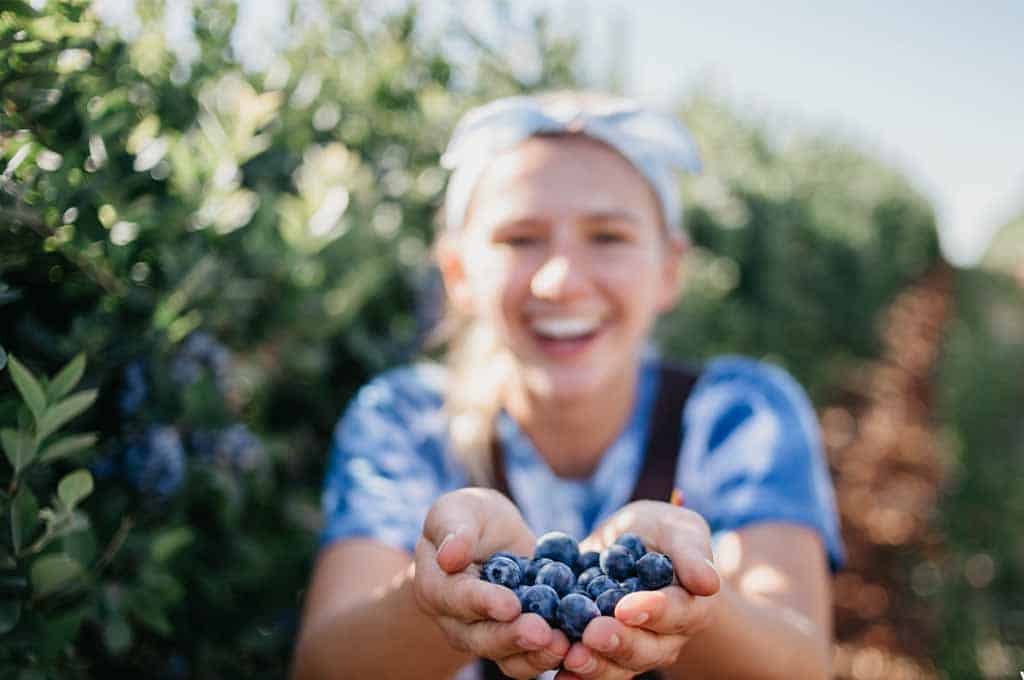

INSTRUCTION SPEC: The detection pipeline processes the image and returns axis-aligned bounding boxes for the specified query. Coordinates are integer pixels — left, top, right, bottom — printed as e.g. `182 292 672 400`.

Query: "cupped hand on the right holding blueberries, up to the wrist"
556 501 721 680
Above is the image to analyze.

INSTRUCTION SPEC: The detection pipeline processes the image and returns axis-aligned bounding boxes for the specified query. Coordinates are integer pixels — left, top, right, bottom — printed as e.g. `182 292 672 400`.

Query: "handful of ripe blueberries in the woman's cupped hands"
481 532 675 640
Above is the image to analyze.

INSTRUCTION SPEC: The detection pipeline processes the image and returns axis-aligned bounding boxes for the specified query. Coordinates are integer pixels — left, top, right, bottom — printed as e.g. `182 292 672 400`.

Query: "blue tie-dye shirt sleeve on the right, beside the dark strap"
679 356 846 572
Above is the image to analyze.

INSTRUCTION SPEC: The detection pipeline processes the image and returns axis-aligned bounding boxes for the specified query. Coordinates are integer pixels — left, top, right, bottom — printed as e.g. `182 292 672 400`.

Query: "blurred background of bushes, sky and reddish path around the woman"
0 0 1024 680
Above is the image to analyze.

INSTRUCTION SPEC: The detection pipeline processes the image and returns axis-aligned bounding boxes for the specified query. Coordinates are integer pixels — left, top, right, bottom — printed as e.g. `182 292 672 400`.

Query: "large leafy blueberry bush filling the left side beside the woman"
0 0 574 678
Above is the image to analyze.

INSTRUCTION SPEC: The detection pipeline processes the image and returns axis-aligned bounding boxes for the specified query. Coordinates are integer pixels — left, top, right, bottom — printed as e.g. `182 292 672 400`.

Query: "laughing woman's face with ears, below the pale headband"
441 136 681 400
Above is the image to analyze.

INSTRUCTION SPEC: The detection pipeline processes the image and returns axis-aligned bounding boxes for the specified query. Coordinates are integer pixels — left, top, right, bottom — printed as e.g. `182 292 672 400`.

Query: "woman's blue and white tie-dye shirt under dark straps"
322 353 845 570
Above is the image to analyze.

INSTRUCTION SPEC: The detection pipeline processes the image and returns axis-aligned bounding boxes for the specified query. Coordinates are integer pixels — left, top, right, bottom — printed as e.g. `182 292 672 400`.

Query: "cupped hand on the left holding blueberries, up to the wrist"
414 488 569 678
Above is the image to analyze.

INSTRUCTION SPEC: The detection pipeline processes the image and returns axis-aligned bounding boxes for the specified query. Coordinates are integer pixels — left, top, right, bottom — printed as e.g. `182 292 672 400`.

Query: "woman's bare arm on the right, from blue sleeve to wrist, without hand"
666 522 831 680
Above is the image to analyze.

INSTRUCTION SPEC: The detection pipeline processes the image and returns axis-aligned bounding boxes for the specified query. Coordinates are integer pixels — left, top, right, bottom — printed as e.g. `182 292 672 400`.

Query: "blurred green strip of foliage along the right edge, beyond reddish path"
929 270 1024 679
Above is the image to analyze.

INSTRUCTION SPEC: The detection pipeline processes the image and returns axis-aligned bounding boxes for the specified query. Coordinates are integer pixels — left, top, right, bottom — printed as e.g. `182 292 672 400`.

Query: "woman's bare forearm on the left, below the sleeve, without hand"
292 539 470 680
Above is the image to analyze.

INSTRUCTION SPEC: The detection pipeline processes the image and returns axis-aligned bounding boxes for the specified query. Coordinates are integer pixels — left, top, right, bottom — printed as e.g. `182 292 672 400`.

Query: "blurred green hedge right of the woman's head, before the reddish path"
660 93 939 400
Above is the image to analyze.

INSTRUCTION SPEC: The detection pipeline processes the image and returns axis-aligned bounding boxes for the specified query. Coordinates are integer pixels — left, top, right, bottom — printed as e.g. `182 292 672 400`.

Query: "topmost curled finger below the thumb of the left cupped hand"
416 539 521 624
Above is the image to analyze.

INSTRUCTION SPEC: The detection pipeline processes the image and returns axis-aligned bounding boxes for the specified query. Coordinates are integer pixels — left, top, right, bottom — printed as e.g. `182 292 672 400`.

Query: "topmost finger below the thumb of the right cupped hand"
615 586 712 635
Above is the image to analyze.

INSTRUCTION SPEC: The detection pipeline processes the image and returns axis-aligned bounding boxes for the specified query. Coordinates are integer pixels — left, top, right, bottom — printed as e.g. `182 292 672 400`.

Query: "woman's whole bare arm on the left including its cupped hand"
293 488 569 680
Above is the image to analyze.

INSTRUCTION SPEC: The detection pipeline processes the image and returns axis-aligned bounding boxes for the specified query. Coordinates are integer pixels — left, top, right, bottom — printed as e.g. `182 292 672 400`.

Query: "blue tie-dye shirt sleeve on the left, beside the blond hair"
321 368 444 552
